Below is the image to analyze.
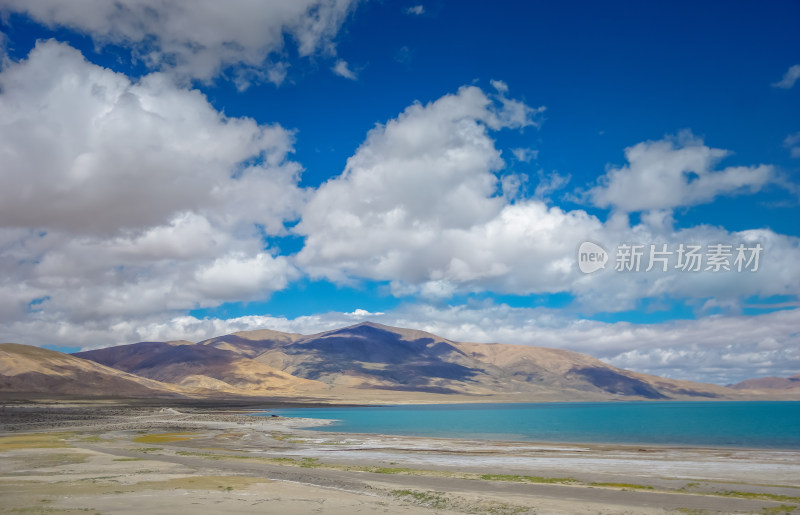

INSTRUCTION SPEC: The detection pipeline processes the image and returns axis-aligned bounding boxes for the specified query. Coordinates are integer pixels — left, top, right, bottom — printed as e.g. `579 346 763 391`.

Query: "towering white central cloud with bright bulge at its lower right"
296 82 580 296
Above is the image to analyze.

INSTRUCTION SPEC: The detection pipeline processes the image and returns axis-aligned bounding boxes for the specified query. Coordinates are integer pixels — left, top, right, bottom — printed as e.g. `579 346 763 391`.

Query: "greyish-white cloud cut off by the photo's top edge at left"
0 0 356 86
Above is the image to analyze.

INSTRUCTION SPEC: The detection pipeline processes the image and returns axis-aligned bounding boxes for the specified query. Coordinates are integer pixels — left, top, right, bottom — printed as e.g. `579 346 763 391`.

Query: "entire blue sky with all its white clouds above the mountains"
0 0 800 383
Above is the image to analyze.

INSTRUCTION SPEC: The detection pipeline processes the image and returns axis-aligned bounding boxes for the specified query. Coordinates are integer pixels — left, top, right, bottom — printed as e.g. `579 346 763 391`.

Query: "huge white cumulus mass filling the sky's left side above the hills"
0 41 305 330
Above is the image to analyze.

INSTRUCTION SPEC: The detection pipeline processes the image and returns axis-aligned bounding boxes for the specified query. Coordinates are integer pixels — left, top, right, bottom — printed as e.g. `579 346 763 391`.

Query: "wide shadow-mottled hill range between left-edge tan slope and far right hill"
70 323 764 402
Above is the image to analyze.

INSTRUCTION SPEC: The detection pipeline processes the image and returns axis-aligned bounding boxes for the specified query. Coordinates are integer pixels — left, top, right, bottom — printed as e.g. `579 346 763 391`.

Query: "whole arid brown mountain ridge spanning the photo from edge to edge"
0 322 800 403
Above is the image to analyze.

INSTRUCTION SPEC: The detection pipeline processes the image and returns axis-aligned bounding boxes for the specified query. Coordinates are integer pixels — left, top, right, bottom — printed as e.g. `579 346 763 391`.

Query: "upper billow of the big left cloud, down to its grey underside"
0 41 299 234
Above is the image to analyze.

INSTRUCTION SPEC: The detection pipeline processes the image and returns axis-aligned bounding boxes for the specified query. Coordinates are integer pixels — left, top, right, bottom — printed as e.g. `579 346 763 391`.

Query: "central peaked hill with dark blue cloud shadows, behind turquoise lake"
240 322 730 400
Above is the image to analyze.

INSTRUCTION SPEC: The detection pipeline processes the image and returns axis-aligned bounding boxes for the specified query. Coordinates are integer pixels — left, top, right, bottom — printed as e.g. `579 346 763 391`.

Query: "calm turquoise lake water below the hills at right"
260 402 800 449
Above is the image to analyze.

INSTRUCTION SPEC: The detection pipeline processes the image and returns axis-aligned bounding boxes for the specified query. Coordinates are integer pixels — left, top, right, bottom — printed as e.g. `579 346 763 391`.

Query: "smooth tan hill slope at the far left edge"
0 343 189 397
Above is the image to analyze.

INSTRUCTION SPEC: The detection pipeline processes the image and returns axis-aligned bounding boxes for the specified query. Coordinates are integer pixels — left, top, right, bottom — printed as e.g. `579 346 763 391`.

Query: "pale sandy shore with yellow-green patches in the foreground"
0 401 800 515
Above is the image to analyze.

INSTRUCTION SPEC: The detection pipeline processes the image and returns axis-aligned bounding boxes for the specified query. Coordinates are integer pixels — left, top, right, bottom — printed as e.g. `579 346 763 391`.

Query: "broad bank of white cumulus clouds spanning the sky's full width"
0 41 800 332
